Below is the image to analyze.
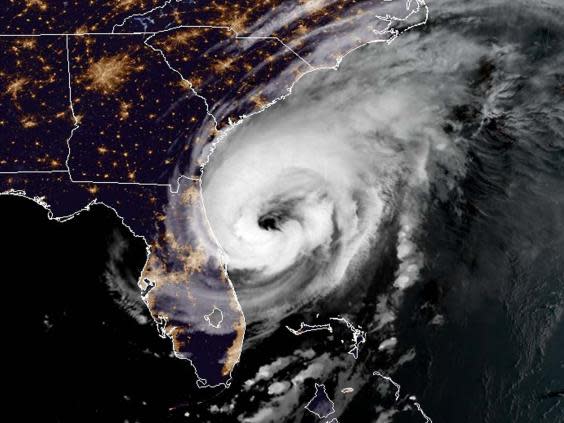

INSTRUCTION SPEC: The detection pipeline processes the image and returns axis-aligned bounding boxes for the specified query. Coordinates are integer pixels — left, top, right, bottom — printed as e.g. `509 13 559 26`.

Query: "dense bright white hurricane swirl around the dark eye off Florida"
203 42 464 328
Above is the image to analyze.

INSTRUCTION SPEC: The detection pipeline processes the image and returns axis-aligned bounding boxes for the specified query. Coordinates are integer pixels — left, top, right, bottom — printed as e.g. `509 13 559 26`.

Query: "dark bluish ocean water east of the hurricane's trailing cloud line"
394 110 564 422
